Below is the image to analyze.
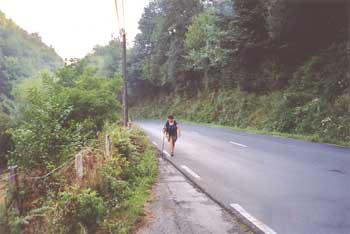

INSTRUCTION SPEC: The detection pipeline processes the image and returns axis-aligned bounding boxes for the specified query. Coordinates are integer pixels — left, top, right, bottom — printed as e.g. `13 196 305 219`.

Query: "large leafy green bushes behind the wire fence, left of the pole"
11 61 121 172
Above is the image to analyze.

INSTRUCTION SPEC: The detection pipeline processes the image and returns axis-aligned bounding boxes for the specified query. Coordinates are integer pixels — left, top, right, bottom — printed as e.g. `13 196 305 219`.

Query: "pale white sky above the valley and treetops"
0 0 149 59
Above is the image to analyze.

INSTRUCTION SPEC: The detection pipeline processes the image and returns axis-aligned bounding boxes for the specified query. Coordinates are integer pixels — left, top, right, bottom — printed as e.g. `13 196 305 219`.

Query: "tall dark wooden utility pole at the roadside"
121 29 129 127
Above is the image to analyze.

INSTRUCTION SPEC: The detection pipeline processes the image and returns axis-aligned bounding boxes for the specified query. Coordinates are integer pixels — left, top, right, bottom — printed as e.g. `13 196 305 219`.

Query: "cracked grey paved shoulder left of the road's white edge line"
137 159 249 234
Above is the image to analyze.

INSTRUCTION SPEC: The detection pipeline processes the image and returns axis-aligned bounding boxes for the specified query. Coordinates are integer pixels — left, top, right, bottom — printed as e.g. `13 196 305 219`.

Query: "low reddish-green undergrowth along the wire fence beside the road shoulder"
0 124 158 234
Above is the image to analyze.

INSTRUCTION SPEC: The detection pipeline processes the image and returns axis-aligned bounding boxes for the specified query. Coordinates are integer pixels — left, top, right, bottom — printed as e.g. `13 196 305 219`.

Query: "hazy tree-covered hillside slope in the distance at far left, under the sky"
0 11 63 95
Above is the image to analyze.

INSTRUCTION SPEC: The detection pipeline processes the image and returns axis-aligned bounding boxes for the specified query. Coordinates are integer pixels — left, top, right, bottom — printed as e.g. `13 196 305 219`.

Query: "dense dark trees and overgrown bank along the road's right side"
125 0 350 144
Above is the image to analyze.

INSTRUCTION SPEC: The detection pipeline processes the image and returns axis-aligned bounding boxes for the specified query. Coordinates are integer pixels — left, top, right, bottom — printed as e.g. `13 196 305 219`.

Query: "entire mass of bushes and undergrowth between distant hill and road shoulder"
0 60 158 234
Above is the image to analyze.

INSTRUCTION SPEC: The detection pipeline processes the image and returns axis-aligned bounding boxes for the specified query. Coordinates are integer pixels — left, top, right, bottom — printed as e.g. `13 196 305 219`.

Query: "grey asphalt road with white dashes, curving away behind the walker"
138 121 350 234
